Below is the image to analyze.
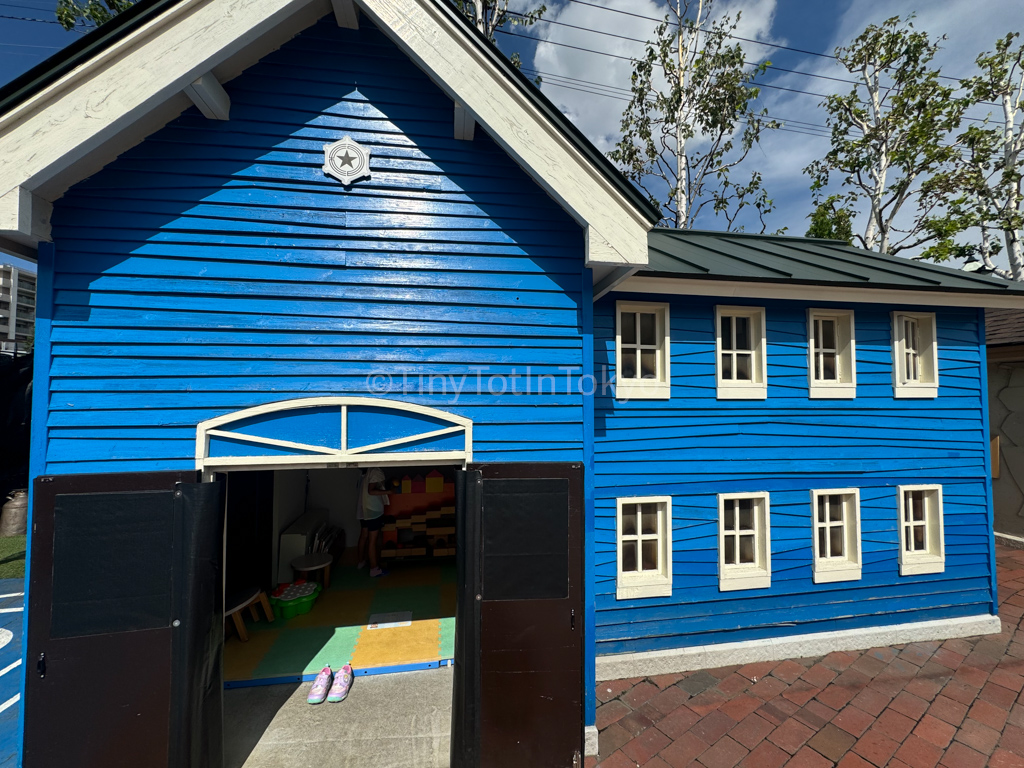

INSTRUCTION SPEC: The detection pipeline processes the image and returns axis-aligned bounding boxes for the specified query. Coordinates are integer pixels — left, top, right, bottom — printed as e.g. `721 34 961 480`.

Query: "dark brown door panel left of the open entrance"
24 472 223 768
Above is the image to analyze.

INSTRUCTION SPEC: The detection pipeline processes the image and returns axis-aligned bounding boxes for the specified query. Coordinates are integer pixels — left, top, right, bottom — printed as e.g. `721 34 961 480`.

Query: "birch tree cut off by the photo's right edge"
925 33 1024 281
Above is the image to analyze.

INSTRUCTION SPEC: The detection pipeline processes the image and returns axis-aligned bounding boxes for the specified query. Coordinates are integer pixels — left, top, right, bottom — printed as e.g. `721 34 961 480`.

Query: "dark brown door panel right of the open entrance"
453 464 584 768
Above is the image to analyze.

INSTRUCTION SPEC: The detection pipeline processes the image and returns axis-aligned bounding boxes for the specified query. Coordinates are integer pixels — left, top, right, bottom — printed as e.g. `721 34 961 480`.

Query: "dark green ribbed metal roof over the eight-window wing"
638 227 1024 299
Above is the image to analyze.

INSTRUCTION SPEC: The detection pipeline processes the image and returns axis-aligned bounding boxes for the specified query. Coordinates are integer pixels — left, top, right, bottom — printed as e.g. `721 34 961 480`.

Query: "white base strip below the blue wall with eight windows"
597 614 1002 681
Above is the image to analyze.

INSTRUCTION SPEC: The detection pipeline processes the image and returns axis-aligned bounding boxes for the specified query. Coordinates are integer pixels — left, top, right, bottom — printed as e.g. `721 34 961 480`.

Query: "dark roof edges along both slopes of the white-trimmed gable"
0 0 662 224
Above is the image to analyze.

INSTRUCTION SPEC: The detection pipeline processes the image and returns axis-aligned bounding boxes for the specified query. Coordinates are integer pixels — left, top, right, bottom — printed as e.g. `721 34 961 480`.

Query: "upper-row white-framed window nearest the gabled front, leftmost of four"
615 301 672 399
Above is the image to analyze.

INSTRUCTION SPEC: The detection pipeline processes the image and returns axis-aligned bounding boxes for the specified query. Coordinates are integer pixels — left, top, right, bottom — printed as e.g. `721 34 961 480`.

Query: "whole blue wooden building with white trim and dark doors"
0 0 1024 768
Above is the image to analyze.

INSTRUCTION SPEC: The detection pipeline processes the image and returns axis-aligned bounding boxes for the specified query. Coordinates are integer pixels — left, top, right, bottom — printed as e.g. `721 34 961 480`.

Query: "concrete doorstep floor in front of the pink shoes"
224 668 452 768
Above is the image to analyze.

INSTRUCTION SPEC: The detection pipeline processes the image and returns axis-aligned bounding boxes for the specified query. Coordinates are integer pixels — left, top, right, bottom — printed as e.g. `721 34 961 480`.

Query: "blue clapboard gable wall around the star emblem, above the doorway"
46 18 584 473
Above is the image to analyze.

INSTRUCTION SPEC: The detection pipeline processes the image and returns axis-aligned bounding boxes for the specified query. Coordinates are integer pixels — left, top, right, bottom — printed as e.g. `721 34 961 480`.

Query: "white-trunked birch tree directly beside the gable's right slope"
608 0 780 231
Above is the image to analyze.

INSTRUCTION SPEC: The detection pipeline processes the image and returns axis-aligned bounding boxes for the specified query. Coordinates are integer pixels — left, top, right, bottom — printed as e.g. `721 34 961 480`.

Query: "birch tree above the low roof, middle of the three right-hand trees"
805 16 968 254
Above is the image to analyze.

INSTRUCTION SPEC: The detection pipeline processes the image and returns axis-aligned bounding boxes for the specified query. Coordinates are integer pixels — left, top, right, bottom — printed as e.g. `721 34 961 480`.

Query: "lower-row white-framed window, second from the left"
718 493 771 592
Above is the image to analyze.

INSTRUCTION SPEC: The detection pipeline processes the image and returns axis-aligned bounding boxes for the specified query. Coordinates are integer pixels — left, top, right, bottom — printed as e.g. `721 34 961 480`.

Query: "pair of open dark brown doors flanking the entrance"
23 464 584 768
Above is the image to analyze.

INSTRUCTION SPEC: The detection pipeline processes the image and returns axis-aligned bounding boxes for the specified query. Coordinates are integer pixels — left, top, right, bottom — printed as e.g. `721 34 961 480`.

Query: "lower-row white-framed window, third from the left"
811 488 861 584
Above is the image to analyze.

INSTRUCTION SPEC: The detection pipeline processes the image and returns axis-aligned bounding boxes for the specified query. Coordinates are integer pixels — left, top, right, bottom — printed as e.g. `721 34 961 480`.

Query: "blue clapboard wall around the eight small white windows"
594 295 993 653
